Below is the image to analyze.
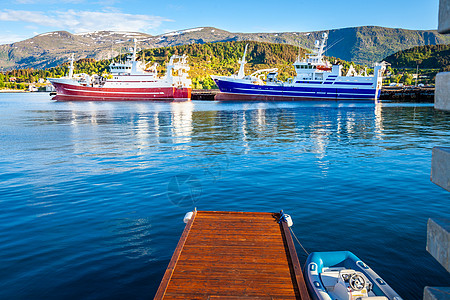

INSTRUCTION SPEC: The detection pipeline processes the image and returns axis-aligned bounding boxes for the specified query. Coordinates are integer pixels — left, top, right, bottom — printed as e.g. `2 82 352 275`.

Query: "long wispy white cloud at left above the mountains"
0 9 172 33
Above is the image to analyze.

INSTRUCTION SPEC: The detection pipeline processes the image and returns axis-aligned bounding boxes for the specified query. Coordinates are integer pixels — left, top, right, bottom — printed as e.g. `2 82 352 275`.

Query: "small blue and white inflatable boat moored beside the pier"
305 251 402 300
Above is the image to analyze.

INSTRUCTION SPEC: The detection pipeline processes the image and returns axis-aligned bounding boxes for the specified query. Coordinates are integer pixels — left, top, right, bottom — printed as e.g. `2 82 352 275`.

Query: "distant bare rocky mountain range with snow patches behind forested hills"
0 26 450 70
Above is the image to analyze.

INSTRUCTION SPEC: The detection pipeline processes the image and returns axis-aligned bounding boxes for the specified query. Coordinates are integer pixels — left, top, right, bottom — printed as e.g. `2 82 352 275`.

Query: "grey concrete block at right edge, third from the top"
431 147 450 192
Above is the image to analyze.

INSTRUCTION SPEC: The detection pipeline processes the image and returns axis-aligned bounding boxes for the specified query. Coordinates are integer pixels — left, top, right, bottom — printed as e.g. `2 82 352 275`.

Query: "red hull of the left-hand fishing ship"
52 82 191 101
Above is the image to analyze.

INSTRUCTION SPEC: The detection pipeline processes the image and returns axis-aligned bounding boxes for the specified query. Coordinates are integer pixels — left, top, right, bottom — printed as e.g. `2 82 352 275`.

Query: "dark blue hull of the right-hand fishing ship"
215 79 381 101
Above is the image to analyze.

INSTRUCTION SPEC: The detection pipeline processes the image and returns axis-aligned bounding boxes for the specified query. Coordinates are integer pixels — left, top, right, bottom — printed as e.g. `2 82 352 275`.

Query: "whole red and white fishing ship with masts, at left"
49 41 191 101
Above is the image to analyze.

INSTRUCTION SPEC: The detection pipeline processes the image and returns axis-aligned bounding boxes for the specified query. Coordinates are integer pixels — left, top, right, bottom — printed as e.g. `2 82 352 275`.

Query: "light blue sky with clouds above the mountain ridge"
0 0 439 44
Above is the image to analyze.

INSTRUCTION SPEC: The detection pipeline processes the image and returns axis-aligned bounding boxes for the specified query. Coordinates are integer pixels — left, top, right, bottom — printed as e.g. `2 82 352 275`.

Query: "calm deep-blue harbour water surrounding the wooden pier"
0 93 450 299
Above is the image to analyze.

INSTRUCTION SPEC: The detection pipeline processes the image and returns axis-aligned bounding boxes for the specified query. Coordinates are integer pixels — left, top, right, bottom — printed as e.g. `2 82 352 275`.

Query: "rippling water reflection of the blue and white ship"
216 103 382 172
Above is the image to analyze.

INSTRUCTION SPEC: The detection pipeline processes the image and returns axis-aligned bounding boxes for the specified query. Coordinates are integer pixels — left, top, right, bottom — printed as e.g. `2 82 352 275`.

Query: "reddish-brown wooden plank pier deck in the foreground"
154 211 310 300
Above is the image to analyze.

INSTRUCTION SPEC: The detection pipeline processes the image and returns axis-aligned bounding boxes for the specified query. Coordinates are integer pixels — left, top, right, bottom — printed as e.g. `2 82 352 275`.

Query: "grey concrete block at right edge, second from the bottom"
427 219 450 274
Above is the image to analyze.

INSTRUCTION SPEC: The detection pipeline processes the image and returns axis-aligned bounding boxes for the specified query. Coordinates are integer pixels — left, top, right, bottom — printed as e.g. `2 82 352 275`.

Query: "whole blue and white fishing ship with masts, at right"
211 33 386 101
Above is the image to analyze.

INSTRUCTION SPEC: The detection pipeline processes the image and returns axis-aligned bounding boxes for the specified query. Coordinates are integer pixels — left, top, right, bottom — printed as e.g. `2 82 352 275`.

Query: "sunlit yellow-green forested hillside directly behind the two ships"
0 41 370 89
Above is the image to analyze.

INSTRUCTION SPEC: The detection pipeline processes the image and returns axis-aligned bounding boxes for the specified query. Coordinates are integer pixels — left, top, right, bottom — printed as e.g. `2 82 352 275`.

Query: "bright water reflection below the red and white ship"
47 102 194 166
